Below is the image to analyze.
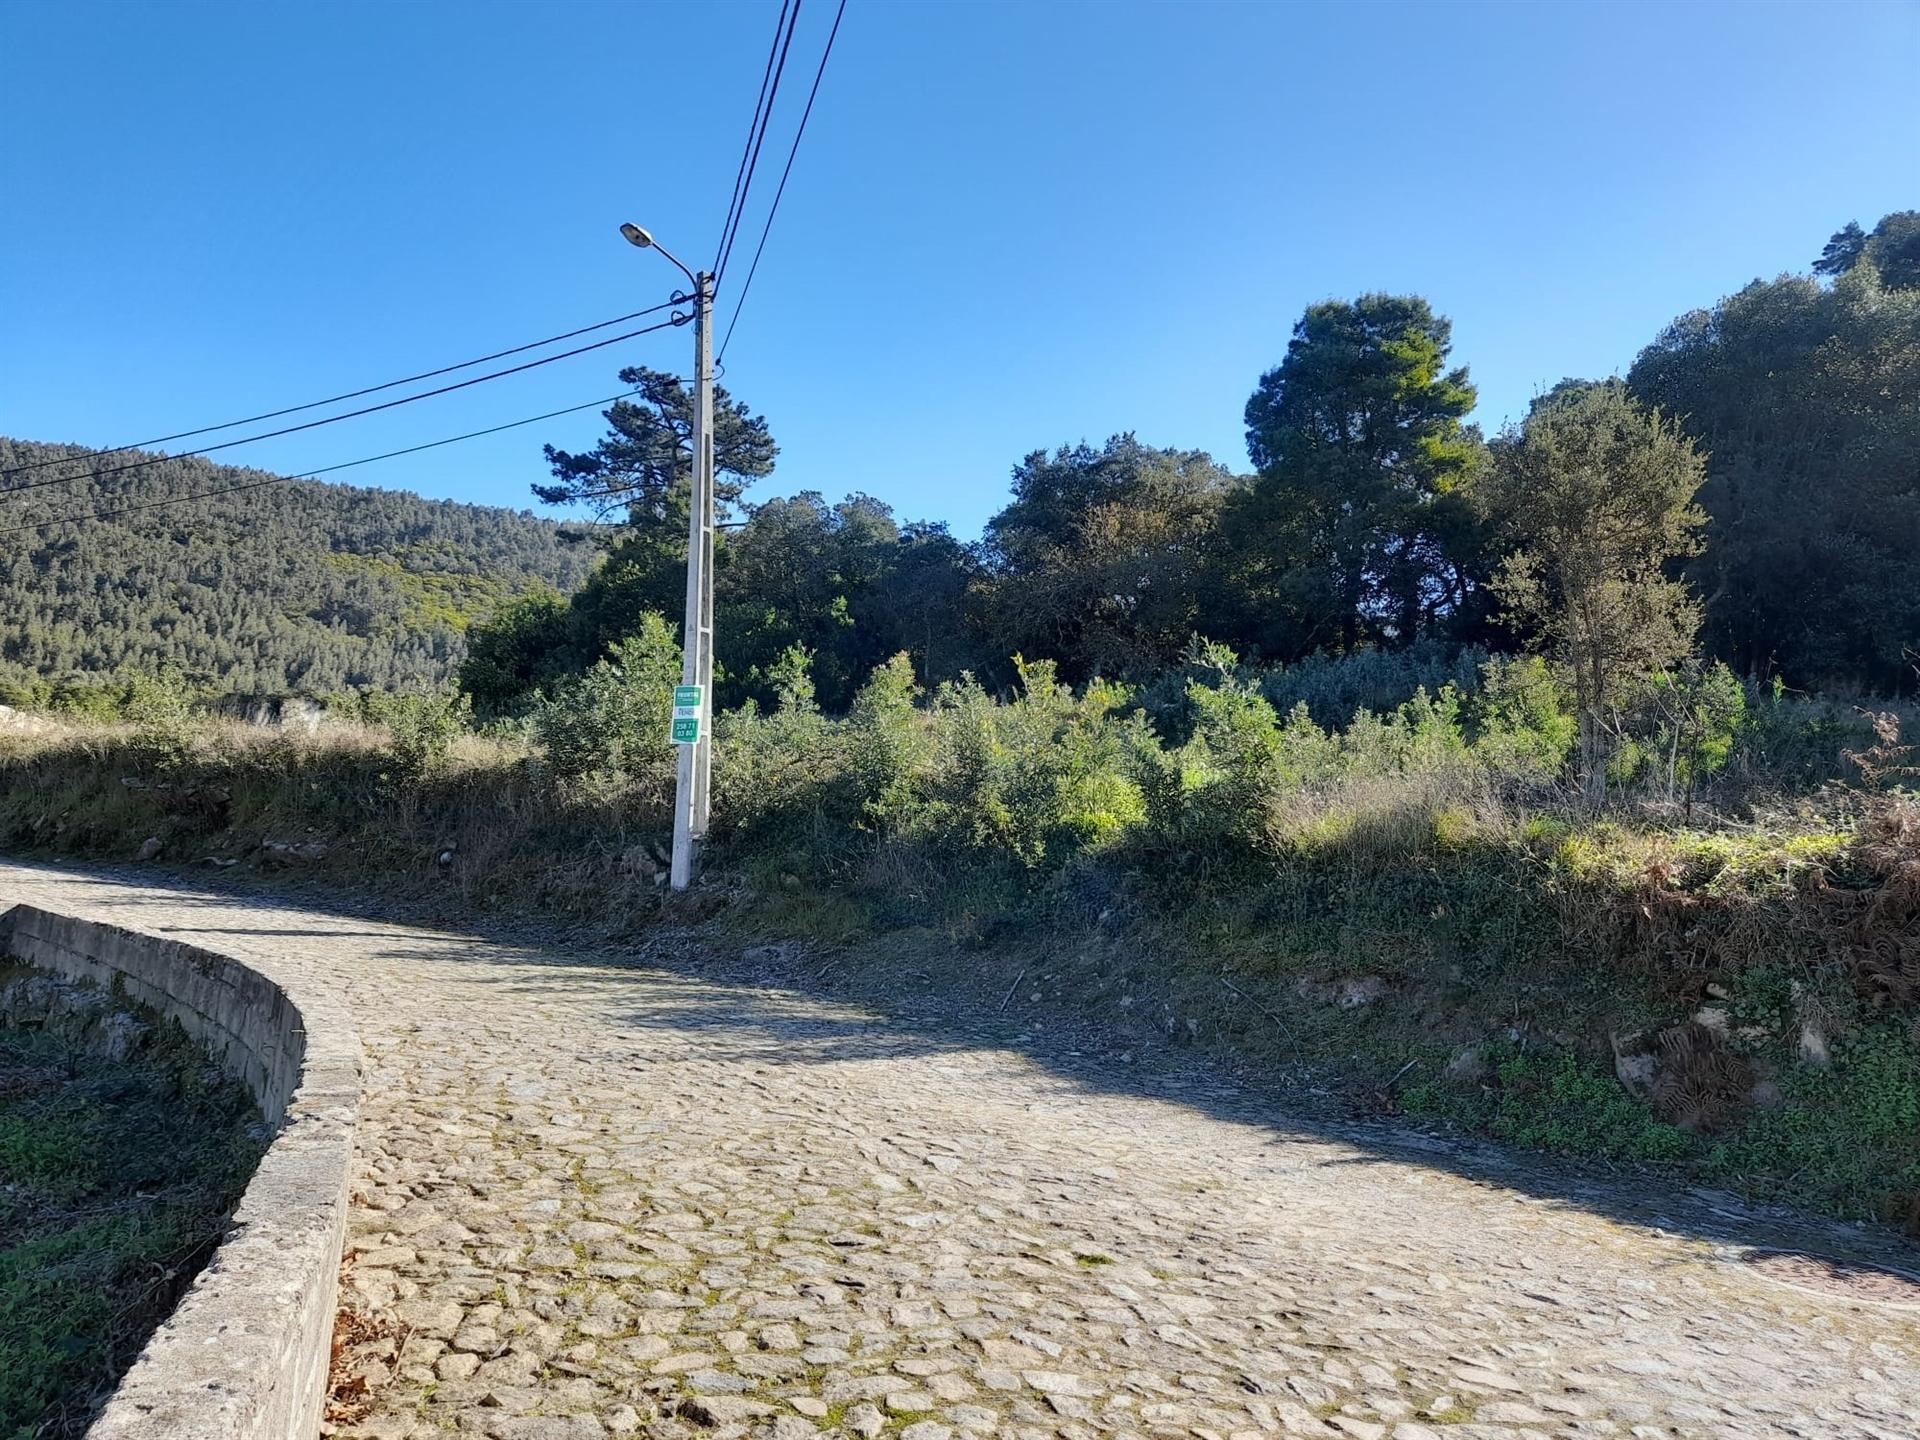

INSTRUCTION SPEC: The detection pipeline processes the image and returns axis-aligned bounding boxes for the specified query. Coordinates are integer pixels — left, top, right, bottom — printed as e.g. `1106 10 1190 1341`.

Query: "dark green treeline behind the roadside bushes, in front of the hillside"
463 211 1920 712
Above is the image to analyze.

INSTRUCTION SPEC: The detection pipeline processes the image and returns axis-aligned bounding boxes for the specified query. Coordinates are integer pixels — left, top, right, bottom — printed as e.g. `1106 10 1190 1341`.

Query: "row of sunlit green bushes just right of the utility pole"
716 647 1571 872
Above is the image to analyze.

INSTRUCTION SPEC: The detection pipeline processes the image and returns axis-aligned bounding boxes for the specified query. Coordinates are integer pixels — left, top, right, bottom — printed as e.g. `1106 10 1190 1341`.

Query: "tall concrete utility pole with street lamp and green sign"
620 225 714 891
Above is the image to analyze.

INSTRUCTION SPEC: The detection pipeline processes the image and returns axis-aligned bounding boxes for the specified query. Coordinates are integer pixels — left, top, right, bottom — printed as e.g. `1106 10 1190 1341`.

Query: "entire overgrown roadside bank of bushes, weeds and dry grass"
0 666 1920 1221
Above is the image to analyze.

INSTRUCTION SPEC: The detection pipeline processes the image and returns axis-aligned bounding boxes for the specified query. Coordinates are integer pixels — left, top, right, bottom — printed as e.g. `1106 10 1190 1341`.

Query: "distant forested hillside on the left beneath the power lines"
0 438 593 697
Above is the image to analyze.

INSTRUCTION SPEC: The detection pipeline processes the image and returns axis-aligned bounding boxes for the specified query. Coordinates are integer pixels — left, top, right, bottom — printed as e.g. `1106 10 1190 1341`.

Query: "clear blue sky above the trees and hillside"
0 0 1920 534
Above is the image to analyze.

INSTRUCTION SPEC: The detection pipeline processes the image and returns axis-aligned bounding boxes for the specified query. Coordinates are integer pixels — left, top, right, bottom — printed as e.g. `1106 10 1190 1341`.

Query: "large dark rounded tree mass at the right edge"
1628 235 1920 693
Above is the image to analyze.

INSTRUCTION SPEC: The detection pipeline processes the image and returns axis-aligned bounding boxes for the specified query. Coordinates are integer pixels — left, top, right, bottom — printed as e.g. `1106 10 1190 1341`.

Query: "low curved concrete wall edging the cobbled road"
0 904 361 1440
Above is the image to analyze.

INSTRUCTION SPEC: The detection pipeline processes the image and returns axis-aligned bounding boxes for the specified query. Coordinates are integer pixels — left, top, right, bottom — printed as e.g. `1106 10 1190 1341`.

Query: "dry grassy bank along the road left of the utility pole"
0 720 683 918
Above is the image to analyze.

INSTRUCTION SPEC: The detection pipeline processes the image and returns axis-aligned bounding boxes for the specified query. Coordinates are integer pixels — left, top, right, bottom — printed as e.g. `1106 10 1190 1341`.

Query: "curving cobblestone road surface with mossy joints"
0 866 1920 1440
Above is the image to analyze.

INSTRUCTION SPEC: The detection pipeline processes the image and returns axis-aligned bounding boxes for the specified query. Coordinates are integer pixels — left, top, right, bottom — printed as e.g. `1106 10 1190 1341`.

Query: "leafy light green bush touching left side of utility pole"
532 614 682 781
